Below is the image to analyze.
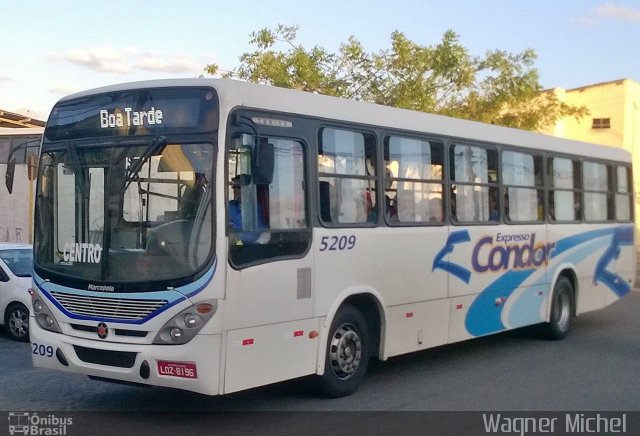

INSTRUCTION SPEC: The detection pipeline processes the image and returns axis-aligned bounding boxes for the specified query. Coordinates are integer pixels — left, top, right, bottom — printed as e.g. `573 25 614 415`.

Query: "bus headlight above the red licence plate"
153 301 217 345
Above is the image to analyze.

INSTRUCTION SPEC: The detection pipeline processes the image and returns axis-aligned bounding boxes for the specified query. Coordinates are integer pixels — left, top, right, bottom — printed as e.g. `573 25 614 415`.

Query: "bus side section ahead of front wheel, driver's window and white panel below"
224 134 318 393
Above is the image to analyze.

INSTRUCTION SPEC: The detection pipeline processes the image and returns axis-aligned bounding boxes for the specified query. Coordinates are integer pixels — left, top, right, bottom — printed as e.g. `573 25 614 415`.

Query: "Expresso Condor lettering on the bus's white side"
471 233 556 272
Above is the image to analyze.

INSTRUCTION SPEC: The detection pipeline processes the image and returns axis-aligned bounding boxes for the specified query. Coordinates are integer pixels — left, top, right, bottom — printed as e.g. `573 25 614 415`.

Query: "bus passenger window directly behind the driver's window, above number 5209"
318 128 378 224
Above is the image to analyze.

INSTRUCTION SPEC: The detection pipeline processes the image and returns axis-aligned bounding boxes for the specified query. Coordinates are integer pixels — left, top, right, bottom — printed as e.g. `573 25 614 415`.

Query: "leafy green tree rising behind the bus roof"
205 25 588 130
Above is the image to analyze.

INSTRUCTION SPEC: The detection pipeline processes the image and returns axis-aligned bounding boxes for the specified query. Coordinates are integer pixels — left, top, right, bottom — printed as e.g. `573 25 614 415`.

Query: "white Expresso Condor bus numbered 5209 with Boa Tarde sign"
31 79 635 397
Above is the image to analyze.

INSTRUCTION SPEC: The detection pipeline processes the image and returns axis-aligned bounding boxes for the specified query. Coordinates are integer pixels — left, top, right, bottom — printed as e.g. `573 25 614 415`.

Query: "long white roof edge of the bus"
55 79 631 162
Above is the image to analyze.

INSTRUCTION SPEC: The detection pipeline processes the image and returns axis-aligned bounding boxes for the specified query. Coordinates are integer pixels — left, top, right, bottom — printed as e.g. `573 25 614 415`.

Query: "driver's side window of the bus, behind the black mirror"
227 132 311 269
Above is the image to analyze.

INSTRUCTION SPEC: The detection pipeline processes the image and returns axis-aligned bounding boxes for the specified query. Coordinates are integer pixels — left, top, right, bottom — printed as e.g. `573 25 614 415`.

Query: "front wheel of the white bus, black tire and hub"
316 305 370 398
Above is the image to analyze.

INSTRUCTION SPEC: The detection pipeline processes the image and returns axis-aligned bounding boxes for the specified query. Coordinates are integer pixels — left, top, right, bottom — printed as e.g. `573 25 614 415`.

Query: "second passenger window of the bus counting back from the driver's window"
384 136 444 224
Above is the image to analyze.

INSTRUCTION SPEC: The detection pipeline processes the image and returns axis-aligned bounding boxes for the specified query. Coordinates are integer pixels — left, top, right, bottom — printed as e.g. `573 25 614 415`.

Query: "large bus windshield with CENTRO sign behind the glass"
34 141 215 290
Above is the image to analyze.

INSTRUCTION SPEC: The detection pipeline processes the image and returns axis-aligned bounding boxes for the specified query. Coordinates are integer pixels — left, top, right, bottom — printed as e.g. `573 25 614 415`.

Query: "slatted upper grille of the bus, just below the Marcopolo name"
51 292 167 320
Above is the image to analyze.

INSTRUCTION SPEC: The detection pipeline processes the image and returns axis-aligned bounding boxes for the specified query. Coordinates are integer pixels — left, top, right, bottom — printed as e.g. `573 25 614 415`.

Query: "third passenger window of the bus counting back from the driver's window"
450 144 500 223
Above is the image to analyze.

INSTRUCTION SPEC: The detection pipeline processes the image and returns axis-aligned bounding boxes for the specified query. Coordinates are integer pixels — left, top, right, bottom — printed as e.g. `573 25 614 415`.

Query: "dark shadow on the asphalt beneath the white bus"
67 293 640 412
